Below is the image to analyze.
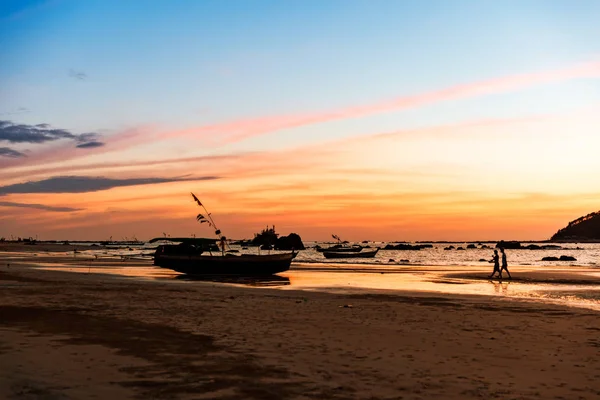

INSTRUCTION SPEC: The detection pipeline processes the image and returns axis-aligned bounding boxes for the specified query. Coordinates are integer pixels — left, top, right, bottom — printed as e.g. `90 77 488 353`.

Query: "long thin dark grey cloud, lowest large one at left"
0 176 219 195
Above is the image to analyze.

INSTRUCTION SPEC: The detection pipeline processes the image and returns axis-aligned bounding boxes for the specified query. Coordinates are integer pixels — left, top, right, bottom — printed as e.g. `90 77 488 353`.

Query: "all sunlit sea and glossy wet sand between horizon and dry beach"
15 242 600 311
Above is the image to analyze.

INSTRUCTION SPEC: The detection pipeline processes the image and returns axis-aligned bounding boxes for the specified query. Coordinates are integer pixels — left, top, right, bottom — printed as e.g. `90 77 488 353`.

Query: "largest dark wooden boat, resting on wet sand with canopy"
154 245 298 276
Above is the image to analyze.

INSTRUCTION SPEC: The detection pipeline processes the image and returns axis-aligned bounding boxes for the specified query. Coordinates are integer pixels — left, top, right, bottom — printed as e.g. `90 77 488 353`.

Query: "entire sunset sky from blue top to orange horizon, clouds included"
0 0 600 241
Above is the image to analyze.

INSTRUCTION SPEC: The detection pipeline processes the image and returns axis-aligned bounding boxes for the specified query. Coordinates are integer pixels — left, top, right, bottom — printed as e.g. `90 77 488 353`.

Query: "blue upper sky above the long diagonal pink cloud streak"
0 0 600 131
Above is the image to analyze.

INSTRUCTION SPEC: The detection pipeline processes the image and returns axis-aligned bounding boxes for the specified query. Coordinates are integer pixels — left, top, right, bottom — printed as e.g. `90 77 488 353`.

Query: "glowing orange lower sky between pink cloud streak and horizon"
0 97 600 241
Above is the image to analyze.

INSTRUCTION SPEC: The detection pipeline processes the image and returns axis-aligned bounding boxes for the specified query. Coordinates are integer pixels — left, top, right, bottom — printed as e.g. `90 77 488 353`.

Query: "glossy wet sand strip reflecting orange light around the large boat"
17 255 600 309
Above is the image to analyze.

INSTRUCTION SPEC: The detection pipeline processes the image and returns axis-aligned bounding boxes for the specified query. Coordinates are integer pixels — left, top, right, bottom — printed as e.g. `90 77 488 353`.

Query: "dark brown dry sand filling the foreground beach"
0 250 600 400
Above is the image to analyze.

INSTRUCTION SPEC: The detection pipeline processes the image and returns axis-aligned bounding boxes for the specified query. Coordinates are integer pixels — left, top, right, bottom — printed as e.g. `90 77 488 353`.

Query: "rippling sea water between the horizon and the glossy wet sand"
72 242 600 267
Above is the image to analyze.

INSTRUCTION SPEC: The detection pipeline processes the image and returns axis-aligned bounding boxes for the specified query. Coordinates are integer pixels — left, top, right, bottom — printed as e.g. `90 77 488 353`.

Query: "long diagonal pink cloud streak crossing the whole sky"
0 62 600 182
